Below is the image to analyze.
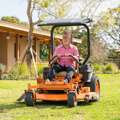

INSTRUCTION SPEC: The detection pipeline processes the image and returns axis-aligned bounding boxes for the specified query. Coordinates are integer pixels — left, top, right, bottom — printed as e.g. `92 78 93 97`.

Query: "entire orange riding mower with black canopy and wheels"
18 18 100 107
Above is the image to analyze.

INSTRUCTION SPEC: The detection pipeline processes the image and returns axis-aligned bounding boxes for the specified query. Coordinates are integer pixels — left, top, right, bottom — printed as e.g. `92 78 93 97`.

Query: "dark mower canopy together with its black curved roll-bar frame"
38 18 92 65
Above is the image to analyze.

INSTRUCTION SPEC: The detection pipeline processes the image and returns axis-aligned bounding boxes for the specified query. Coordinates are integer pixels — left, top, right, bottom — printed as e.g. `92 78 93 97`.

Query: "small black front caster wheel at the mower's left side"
25 91 36 106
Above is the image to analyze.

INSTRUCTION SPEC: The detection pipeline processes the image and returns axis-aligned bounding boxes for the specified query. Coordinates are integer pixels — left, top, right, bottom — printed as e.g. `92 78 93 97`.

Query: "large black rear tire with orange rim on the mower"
85 75 100 102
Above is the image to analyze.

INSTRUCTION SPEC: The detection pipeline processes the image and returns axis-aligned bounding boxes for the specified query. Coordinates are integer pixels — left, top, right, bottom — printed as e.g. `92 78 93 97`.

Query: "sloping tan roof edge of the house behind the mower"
0 20 82 43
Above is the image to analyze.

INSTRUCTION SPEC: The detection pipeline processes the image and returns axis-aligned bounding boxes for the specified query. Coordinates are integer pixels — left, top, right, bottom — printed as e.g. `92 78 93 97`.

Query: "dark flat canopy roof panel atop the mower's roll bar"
38 18 92 26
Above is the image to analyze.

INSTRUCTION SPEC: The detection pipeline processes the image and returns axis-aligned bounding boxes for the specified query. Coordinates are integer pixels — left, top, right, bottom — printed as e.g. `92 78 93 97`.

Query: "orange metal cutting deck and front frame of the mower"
25 78 97 101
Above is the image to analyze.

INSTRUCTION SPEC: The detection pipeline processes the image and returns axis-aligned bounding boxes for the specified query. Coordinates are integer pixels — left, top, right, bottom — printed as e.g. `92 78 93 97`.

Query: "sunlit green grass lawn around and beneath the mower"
0 74 120 120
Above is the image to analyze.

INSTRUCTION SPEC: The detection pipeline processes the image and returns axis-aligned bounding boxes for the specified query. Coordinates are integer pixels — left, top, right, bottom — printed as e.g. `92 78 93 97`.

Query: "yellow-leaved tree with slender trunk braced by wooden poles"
27 0 74 66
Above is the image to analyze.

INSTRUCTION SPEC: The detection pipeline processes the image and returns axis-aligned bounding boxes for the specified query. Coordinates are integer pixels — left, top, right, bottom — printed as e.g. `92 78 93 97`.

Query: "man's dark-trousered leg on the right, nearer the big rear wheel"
65 66 75 83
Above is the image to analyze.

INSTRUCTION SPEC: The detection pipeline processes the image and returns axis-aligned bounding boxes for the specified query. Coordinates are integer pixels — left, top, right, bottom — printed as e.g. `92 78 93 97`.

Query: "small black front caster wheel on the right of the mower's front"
67 91 77 107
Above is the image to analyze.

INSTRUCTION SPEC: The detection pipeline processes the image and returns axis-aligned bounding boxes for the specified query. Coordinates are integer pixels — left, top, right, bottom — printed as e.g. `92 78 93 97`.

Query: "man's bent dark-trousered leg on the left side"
47 65 65 81
